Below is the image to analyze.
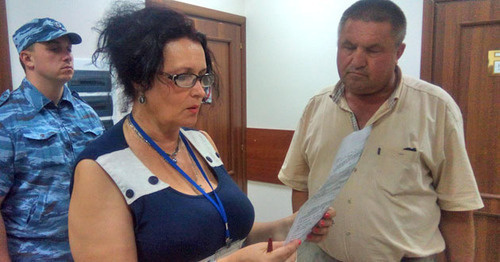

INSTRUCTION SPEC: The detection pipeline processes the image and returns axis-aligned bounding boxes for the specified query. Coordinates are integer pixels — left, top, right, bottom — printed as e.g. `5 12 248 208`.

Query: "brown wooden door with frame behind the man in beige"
421 0 500 261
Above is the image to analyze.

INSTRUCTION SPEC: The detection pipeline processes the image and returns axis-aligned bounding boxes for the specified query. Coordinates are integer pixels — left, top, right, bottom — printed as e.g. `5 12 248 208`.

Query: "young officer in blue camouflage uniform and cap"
0 18 104 261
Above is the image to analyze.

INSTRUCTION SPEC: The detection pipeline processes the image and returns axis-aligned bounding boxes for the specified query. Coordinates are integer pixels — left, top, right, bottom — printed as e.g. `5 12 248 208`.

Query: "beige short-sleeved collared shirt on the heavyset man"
278 72 483 261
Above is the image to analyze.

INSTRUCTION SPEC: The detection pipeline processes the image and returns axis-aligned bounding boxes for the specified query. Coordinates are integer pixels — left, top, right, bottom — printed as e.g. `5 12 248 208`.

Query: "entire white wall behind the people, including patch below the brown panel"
6 0 423 221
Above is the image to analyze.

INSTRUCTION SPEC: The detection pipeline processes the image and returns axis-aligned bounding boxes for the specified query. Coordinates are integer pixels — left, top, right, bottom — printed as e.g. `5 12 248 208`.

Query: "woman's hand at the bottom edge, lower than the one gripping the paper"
217 240 301 262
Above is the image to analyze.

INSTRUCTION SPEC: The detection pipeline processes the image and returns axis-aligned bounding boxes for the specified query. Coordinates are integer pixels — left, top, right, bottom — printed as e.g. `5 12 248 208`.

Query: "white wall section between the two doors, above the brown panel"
245 0 423 130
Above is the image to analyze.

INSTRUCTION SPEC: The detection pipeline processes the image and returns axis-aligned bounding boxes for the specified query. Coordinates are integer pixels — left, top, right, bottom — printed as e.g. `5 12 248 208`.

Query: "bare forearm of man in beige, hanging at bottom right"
439 210 475 262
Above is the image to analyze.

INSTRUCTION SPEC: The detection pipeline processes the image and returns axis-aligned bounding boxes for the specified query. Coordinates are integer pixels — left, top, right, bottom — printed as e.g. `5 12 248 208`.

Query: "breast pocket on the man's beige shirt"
374 147 422 195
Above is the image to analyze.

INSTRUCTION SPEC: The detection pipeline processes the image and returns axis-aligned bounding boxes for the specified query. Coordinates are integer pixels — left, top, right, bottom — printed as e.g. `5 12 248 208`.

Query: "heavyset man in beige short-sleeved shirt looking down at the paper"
278 0 483 262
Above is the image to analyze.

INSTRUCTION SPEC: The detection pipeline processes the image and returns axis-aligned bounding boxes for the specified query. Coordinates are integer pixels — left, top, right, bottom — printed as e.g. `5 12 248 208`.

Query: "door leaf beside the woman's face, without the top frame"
192 17 246 190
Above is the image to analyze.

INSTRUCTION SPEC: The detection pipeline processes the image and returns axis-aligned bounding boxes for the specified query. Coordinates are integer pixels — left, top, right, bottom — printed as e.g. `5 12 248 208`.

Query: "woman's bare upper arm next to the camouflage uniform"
68 160 137 261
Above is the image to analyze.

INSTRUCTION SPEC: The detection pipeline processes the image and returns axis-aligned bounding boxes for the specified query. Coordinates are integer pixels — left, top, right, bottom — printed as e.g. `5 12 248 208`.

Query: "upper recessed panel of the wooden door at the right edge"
455 21 500 193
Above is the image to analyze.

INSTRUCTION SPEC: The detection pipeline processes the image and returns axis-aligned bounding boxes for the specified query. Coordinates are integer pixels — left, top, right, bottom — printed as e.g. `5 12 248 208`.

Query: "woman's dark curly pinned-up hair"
92 2 218 100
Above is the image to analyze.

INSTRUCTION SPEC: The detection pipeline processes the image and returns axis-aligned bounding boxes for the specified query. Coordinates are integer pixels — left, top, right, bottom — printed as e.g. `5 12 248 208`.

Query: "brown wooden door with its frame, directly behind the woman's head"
146 0 247 192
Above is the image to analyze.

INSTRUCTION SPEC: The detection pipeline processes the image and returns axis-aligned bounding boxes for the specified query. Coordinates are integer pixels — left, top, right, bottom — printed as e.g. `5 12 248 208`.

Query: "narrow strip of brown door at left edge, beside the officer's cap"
0 0 12 94
